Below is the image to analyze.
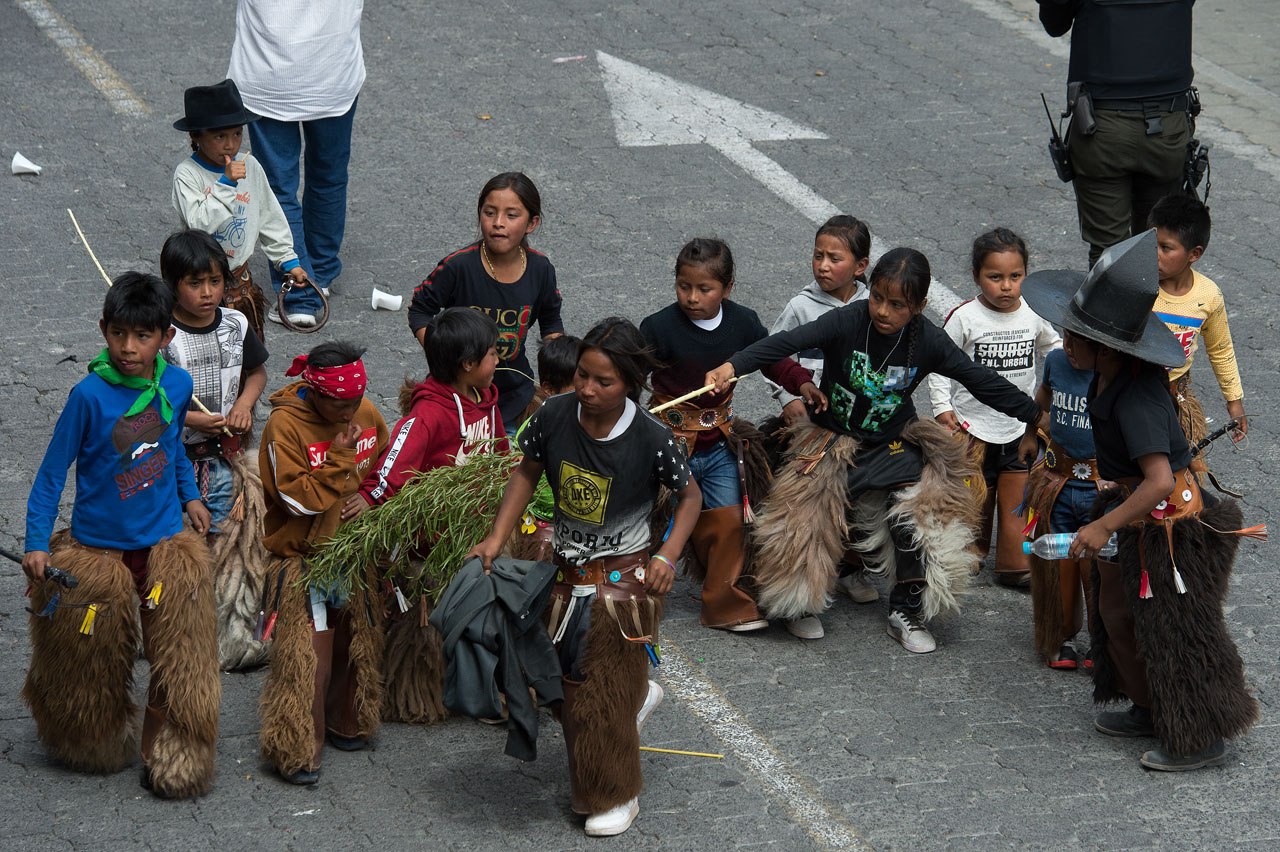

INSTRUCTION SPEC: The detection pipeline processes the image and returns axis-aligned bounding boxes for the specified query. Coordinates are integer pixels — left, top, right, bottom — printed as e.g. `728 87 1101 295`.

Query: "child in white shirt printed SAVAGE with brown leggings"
929 228 1062 586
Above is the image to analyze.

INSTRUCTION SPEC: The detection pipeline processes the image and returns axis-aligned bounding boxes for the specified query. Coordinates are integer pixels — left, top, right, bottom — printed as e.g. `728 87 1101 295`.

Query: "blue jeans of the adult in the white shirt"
248 99 360 313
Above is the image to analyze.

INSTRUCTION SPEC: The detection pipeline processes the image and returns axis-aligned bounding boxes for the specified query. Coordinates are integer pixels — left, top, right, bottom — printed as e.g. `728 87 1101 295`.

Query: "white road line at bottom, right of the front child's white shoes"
659 636 872 852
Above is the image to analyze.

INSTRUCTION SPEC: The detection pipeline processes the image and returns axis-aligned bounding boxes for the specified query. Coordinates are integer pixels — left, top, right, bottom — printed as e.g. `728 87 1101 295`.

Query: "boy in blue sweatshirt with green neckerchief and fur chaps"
22 272 221 797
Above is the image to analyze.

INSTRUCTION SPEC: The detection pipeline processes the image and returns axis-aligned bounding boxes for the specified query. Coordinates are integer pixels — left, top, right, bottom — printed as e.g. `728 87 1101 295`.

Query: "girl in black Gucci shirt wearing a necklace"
408 171 564 435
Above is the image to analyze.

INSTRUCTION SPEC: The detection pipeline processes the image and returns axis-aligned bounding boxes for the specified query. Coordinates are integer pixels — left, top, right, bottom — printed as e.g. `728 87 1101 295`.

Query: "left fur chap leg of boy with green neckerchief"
22 539 140 773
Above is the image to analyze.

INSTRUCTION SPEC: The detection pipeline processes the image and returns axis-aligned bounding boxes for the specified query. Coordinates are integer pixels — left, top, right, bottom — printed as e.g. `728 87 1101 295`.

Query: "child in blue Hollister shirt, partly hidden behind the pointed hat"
1019 345 1114 670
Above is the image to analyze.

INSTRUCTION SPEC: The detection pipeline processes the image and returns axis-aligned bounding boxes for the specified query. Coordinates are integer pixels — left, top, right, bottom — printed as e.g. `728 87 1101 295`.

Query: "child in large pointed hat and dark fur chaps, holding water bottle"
1021 232 1265 771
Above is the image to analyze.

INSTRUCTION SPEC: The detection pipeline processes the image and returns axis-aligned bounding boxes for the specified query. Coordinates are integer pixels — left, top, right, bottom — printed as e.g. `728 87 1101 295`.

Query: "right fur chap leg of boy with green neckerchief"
147 531 223 798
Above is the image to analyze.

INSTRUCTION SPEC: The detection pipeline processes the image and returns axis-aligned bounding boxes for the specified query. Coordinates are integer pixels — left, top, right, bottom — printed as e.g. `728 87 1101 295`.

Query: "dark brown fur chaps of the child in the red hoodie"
383 599 449 725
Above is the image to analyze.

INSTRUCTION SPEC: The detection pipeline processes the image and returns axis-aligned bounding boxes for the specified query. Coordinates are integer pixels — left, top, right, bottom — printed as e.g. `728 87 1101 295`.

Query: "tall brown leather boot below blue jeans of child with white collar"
690 505 769 632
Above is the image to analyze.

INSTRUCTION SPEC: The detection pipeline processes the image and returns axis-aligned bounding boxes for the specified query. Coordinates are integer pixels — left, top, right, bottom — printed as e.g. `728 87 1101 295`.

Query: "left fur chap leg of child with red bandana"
257 556 316 775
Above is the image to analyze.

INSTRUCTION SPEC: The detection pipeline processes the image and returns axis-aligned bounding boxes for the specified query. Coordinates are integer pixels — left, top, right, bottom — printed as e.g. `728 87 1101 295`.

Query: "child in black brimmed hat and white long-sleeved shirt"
173 79 320 332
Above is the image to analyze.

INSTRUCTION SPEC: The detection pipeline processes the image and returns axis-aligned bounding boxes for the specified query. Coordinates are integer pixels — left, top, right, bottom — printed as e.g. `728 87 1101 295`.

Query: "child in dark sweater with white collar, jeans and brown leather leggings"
640 238 820 632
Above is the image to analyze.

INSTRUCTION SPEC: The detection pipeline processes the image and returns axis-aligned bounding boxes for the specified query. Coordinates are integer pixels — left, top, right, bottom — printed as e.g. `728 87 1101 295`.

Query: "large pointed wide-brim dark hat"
1023 230 1187 367
